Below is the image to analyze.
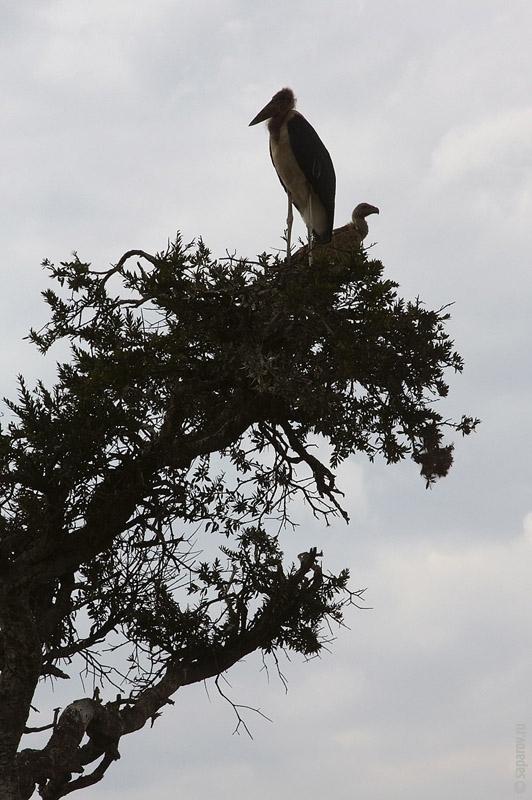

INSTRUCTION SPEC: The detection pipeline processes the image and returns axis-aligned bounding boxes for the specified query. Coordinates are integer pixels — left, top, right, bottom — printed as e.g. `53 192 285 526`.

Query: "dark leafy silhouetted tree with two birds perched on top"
0 237 476 800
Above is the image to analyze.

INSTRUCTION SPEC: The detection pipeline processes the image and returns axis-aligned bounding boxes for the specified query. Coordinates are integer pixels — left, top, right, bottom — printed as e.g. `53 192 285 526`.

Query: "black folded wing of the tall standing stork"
287 112 336 244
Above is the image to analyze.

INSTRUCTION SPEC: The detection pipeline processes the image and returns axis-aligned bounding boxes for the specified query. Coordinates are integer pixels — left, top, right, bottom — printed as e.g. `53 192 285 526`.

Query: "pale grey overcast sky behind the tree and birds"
0 0 532 800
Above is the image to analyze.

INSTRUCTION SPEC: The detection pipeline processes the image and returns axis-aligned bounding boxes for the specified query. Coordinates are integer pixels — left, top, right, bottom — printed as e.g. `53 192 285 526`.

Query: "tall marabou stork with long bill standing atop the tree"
249 88 336 260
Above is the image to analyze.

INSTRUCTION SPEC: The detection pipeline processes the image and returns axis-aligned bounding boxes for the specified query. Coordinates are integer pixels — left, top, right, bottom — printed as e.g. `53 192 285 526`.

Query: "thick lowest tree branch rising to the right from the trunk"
17 548 321 800
